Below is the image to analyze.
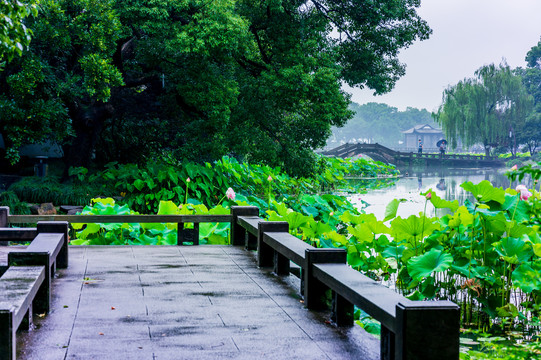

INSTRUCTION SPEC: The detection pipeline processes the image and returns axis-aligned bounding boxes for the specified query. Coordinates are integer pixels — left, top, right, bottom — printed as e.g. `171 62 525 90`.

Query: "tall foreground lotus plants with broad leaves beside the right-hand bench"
320 181 541 329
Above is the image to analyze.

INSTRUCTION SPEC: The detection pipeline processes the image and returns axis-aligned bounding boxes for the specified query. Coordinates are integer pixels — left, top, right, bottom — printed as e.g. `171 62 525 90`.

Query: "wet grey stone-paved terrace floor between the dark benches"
17 246 379 360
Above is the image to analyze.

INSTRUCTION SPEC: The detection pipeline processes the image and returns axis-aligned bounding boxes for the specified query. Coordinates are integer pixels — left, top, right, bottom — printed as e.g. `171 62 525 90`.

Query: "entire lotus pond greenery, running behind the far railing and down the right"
19 159 541 359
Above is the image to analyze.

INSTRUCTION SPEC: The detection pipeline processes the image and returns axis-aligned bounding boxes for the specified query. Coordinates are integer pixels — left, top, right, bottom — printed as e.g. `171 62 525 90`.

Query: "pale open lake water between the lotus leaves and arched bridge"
349 168 533 220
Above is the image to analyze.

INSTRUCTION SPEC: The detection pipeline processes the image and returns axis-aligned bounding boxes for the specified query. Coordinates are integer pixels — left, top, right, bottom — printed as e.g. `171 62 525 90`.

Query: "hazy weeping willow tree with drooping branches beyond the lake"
436 63 533 156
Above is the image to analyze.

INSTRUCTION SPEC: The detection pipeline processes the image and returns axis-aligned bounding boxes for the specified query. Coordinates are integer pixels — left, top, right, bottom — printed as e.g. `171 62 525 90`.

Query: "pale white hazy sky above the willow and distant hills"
344 0 541 111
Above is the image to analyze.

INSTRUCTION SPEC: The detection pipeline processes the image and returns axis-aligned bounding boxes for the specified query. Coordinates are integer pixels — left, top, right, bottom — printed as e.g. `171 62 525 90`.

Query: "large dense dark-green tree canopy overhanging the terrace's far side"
0 0 430 173
